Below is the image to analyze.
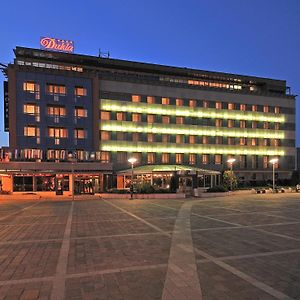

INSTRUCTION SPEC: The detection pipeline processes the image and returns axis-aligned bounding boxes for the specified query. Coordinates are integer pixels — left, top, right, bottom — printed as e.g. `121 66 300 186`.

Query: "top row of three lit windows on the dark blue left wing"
23 81 87 97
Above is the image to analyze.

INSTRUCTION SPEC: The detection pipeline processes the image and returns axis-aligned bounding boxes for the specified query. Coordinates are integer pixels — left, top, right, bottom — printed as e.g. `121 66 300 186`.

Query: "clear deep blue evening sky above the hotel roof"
0 0 300 145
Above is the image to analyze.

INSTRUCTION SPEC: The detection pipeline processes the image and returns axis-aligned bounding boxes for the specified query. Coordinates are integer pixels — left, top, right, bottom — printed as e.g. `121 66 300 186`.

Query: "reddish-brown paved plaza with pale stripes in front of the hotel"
0 194 300 300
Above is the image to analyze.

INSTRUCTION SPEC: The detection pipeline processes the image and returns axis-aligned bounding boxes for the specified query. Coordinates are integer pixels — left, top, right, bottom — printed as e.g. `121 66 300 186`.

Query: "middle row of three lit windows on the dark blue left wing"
23 103 87 118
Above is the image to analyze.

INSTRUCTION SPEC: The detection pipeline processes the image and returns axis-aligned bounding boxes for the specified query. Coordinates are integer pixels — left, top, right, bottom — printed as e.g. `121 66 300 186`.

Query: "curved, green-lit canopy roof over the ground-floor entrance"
118 165 221 175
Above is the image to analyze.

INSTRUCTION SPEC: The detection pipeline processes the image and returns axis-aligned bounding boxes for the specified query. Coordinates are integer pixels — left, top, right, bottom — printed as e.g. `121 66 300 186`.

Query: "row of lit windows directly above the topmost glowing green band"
131 95 280 114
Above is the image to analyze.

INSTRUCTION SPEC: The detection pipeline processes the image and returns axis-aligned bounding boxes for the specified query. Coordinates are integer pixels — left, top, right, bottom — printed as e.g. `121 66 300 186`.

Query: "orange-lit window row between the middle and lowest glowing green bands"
100 131 280 147
